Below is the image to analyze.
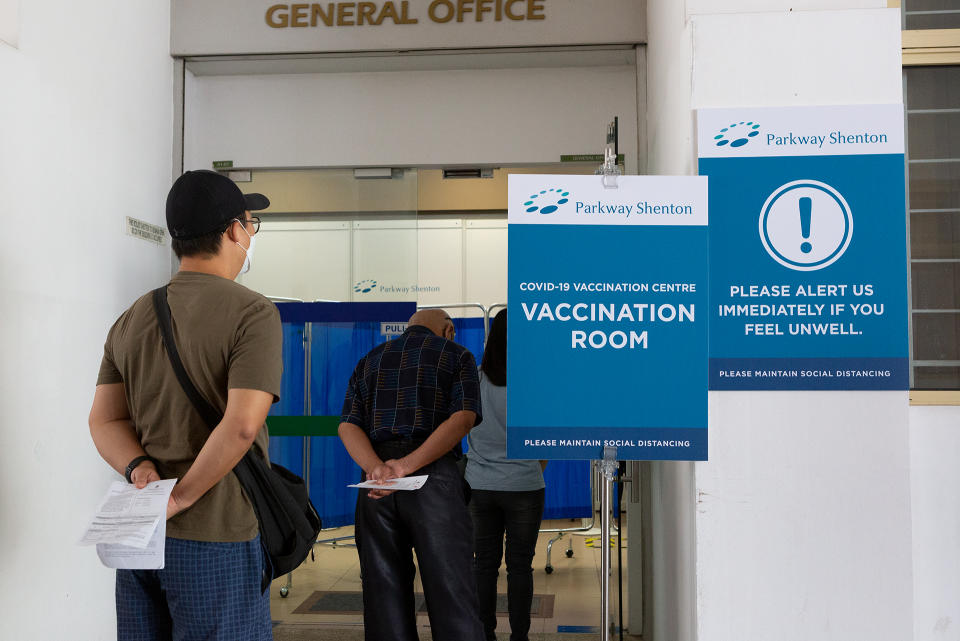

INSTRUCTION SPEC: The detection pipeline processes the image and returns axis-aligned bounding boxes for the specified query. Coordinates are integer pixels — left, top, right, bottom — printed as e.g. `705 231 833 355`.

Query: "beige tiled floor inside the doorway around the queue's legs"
270 520 629 634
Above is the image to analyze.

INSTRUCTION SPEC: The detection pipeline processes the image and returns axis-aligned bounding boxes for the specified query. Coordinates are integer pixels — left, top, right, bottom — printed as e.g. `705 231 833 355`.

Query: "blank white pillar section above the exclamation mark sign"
691 8 903 109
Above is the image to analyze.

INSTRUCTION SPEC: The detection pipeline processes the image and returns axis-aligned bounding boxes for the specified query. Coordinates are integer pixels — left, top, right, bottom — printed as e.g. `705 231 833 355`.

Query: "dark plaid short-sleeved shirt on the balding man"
341 325 481 443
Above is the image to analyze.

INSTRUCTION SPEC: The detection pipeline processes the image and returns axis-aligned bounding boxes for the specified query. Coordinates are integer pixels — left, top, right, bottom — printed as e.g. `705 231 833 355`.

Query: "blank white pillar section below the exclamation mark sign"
696 392 913 641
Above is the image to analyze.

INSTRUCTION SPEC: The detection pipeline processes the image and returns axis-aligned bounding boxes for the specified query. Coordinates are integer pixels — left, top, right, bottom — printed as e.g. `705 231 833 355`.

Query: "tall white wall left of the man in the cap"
0 0 173 641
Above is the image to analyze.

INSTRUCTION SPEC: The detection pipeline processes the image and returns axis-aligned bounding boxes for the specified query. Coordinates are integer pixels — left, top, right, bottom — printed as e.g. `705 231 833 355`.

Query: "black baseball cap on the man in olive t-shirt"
167 169 270 240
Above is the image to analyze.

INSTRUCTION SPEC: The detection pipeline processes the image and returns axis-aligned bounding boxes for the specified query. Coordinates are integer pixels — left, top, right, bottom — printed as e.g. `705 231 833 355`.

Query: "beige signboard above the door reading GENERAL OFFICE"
171 0 646 57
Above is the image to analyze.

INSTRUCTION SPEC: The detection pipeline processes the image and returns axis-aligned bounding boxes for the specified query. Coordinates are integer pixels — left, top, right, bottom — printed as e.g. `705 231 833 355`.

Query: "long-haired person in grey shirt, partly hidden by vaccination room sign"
465 309 546 641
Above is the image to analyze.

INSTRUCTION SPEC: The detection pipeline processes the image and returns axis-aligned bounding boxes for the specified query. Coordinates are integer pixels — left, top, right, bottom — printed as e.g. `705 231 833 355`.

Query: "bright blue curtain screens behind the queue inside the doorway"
270 305 591 527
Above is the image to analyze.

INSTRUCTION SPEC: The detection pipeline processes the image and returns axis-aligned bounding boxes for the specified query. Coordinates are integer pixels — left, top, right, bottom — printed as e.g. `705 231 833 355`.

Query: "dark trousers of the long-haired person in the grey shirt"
470 489 544 641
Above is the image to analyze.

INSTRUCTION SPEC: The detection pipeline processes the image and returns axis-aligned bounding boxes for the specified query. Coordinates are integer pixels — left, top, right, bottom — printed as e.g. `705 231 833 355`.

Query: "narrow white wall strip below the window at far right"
910 407 960 641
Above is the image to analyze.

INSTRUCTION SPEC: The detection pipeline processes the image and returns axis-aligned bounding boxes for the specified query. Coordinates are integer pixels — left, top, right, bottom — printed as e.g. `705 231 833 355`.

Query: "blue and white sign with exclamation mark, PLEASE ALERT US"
697 105 909 390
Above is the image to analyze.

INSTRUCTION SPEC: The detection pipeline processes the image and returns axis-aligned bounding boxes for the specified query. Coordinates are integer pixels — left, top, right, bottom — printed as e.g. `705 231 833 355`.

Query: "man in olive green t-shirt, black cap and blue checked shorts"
90 171 282 641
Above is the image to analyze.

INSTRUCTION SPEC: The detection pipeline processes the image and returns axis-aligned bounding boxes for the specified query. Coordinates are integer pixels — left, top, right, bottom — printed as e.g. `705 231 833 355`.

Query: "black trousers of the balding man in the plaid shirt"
356 443 483 641
